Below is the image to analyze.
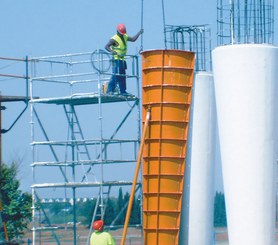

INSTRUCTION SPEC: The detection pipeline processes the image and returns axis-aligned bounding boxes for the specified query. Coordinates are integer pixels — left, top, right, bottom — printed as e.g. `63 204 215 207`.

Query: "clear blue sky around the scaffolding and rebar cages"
0 0 277 193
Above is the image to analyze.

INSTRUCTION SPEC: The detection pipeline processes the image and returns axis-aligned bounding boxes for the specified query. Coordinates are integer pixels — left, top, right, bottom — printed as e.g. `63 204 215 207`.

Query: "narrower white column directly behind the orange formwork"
188 72 216 245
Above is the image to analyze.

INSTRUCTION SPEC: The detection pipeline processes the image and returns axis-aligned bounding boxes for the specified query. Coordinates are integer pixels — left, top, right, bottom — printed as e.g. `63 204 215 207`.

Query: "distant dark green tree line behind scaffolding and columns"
27 188 227 230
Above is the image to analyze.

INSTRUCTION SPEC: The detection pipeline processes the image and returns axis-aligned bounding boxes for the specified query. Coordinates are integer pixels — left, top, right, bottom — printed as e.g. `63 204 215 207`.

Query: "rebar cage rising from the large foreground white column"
217 0 274 45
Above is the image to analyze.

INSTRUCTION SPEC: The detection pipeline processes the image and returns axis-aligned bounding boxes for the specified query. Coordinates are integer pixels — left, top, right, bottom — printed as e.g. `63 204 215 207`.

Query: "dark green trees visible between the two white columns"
214 192 227 227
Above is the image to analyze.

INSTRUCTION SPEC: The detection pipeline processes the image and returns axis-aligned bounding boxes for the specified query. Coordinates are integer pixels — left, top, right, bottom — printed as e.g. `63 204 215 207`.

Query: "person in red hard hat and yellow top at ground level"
90 220 115 245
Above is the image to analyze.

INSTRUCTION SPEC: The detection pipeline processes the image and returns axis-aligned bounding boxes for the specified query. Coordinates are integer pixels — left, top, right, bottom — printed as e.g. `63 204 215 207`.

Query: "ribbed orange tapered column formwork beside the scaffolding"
142 50 195 245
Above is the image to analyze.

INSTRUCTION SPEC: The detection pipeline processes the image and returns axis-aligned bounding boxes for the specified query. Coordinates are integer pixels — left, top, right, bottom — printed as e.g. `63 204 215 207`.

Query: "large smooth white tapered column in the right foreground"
212 44 278 245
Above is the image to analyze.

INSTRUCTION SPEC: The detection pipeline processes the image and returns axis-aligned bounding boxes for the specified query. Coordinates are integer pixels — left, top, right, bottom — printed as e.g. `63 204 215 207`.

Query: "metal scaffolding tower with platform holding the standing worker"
29 50 141 244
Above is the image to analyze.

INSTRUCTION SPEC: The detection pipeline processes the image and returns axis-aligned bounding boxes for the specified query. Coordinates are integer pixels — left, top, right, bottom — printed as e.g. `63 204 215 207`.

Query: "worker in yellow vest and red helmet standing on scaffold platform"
105 24 143 96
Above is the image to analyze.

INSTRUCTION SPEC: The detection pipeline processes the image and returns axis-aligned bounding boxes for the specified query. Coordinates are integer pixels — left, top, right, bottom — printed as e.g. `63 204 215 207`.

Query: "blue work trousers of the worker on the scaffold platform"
107 60 126 94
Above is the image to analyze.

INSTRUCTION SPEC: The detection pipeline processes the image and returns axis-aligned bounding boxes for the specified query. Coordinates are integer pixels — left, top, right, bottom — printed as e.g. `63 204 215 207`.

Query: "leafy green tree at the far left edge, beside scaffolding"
0 163 32 240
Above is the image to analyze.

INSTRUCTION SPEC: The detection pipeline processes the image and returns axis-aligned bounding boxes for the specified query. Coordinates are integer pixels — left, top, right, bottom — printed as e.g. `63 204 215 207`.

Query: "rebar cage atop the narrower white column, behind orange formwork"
165 25 211 71
